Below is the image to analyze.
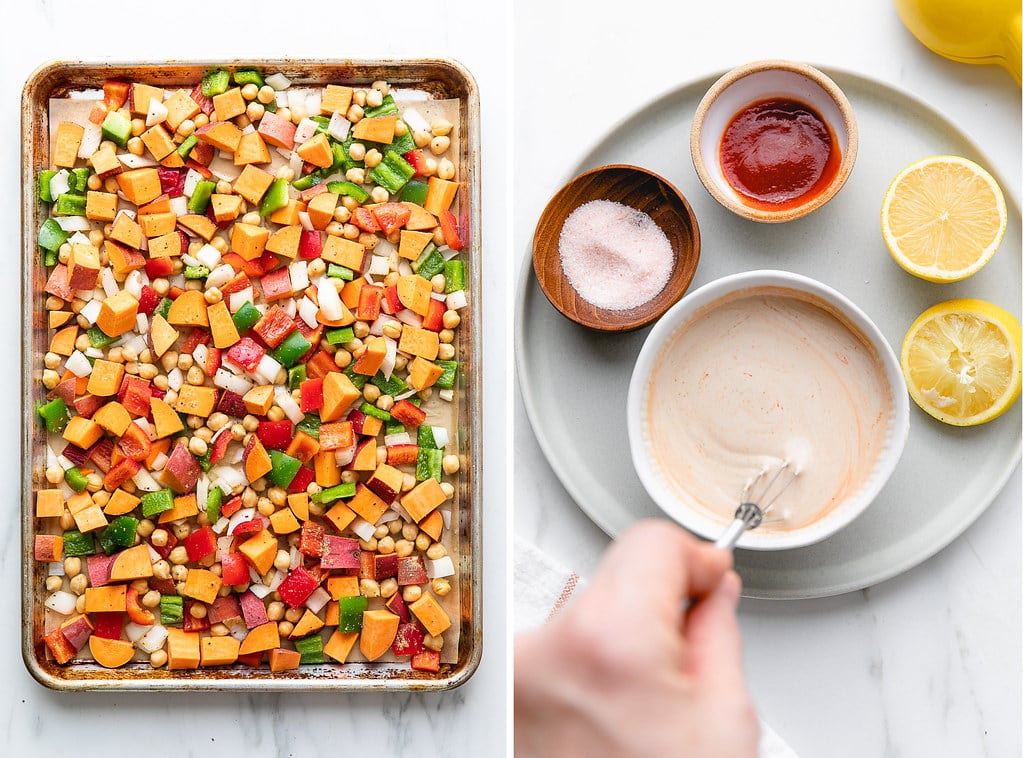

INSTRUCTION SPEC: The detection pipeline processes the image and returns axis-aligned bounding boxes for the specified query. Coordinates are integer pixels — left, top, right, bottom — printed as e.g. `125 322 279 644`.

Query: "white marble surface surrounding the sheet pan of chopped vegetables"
0 0 509 756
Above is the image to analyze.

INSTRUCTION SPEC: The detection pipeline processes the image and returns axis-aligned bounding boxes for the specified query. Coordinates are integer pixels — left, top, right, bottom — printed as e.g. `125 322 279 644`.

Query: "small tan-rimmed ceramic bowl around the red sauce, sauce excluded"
690 60 859 223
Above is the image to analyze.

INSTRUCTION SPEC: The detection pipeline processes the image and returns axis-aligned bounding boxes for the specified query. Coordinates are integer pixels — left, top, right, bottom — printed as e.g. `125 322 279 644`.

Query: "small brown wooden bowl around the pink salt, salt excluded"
533 166 700 331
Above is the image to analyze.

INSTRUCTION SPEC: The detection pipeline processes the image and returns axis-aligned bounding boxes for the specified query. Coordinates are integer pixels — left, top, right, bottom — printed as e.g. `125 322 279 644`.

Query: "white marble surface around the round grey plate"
514 0 1021 758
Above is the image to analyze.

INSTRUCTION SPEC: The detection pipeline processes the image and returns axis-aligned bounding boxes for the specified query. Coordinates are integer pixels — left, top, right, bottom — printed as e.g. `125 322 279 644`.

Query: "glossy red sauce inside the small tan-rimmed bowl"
720 97 842 211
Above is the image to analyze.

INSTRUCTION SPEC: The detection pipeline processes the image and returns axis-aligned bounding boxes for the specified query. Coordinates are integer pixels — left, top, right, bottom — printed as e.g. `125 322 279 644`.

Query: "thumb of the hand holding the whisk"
684 571 746 694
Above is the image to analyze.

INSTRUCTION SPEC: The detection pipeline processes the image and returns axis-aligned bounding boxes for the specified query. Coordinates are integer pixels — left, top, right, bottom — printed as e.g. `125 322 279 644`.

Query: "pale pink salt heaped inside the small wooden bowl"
558 200 674 311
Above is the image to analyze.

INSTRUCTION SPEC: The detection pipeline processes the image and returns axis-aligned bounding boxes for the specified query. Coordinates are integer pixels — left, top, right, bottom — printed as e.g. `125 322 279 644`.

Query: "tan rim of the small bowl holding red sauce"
690 58 859 223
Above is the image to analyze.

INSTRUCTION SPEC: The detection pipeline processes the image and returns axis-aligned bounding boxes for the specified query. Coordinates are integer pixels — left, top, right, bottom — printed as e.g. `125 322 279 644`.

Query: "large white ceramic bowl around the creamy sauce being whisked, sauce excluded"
627 271 909 550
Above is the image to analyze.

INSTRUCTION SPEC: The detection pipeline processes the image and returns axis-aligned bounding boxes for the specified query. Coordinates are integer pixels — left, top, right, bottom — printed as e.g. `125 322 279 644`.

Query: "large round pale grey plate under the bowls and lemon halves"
516 70 1023 598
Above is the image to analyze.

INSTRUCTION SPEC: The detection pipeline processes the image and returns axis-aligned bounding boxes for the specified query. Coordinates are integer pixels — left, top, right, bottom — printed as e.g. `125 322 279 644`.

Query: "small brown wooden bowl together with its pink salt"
533 165 700 331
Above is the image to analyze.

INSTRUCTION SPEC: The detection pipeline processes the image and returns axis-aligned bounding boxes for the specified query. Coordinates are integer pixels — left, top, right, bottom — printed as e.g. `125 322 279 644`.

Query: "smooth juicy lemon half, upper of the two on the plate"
881 155 1006 282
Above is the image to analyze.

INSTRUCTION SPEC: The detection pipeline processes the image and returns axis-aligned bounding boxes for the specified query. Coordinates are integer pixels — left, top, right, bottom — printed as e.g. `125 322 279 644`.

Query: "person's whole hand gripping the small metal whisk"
515 521 759 758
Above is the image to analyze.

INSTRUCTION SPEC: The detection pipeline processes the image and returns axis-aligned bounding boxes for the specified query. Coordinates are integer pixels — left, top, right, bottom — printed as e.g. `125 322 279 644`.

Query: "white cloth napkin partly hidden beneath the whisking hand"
515 537 798 758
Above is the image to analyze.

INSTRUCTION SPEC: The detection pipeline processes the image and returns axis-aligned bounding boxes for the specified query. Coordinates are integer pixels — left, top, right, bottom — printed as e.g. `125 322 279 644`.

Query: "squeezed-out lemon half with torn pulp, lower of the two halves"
901 298 1023 427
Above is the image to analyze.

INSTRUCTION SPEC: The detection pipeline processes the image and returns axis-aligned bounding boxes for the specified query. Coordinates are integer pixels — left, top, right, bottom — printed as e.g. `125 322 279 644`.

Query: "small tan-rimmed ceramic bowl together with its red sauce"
690 60 859 223
